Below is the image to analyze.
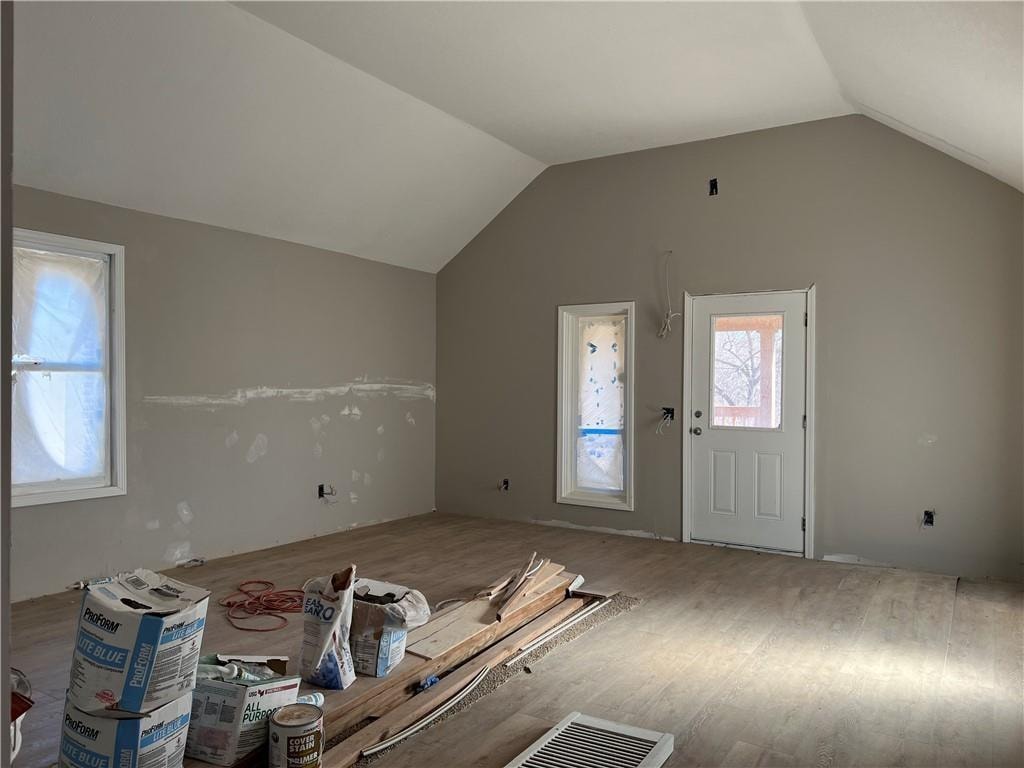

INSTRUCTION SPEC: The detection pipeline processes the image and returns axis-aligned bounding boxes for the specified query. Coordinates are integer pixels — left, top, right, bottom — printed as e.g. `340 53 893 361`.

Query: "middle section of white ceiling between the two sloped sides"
242 2 853 164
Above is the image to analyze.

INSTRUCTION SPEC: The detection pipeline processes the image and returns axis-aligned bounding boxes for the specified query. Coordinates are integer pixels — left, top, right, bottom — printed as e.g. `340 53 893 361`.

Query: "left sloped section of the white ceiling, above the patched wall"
13 2 544 272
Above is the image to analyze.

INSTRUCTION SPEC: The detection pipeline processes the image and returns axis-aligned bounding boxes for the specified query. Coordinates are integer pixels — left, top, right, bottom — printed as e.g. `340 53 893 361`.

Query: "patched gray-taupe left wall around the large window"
11 187 435 599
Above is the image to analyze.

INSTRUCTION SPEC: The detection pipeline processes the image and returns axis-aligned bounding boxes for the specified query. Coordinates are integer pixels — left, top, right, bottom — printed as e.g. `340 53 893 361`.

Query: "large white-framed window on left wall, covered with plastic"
11 229 126 506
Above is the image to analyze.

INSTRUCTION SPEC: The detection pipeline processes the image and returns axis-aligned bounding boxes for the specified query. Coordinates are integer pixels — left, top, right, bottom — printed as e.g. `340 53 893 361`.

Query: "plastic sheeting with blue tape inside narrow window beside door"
577 315 626 490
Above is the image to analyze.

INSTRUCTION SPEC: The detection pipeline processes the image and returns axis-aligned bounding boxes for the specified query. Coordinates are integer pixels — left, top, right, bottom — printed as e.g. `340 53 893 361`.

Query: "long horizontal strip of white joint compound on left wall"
142 378 435 411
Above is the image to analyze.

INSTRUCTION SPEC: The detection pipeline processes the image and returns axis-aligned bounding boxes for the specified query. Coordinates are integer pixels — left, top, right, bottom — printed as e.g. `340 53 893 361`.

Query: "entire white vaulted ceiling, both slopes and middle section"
14 2 1024 271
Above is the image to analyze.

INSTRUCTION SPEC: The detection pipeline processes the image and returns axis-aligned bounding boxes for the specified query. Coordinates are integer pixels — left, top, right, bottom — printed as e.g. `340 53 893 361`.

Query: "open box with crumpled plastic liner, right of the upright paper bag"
349 579 430 677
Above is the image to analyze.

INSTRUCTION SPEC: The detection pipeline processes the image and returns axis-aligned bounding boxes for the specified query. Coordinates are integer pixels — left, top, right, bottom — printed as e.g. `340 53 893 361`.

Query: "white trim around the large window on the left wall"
10 227 128 507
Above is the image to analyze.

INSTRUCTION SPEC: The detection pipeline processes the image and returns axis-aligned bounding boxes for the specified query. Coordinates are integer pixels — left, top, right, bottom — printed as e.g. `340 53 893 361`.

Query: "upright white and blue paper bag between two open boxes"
299 565 355 690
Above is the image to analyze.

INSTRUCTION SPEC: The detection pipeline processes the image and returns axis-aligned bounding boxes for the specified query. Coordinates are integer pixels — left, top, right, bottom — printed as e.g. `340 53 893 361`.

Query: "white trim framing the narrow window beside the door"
555 301 636 512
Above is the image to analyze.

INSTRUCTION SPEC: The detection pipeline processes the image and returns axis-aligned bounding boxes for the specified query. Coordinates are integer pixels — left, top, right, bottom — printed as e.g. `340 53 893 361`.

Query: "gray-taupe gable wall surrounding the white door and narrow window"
437 117 1024 579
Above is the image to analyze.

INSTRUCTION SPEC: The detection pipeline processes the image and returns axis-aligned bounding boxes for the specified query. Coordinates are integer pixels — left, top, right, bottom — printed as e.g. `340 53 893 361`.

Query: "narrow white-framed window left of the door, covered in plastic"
558 301 635 510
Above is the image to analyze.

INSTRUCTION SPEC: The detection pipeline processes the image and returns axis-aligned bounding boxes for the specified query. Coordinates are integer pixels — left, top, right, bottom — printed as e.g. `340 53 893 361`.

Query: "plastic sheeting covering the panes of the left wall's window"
11 247 110 485
